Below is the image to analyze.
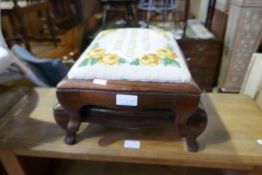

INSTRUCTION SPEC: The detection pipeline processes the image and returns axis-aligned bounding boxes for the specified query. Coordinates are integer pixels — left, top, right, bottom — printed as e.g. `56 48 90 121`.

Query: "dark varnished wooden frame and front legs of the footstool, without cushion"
54 79 206 151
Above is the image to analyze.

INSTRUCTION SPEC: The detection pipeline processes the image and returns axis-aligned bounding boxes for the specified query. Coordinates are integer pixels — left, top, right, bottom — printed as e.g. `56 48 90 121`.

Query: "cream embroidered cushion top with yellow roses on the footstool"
68 28 191 83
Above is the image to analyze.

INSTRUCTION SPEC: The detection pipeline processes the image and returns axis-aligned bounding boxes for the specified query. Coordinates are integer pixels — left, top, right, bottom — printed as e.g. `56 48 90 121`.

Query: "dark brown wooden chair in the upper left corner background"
2 2 58 50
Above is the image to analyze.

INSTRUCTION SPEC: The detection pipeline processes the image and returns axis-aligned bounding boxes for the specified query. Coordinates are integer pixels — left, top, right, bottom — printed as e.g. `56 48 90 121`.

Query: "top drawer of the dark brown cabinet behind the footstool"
186 56 219 67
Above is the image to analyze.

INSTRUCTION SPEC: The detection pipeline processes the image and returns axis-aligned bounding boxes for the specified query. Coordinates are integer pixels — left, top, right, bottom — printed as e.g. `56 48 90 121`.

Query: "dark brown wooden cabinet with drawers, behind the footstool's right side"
178 38 222 91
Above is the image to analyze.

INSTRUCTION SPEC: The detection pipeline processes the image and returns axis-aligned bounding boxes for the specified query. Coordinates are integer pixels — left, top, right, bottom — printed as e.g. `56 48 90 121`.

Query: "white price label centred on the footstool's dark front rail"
116 94 138 106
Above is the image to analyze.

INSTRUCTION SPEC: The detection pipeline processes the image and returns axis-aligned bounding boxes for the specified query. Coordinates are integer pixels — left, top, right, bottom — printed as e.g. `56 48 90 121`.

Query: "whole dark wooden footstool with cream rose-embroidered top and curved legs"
54 29 207 151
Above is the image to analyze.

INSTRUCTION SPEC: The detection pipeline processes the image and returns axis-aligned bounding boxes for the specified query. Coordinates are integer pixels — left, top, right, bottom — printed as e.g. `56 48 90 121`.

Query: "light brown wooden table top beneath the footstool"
0 88 262 169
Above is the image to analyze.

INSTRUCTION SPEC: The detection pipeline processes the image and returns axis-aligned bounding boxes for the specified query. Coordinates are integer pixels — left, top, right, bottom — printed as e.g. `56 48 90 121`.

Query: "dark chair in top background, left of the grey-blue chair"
100 0 137 28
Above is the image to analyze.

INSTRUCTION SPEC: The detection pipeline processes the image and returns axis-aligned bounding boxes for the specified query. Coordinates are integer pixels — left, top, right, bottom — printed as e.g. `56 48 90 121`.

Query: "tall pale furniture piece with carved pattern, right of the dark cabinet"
219 0 262 92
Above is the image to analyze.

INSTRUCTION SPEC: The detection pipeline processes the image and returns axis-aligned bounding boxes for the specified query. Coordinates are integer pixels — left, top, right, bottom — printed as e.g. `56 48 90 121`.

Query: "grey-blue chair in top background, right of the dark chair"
138 0 176 27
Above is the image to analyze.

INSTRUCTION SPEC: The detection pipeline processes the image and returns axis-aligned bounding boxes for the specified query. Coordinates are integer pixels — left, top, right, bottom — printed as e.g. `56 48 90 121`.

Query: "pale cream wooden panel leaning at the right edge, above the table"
240 53 262 108
